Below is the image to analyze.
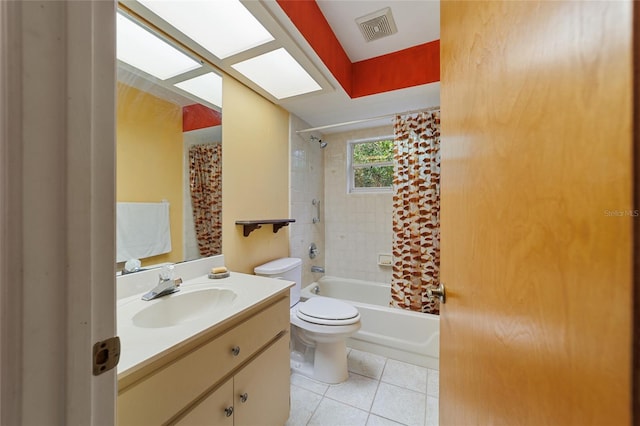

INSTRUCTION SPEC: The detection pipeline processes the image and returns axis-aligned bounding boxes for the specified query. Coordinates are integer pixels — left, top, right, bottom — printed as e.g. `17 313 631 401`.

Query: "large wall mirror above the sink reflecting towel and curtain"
116 11 222 270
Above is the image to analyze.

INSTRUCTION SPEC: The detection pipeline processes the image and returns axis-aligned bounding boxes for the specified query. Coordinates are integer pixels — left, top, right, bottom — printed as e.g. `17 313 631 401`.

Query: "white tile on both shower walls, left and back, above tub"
289 120 393 285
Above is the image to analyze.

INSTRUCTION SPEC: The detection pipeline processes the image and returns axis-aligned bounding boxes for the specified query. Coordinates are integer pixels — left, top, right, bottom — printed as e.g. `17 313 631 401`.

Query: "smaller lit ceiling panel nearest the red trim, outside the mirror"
232 48 322 99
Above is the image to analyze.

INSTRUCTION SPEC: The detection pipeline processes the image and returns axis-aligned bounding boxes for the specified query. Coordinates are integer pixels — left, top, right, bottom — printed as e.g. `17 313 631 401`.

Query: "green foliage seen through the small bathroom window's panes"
352 140 393 188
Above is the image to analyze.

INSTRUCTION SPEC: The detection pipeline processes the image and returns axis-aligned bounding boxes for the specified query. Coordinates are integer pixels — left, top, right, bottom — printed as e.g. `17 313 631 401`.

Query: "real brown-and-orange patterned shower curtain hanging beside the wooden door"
391 111 440 314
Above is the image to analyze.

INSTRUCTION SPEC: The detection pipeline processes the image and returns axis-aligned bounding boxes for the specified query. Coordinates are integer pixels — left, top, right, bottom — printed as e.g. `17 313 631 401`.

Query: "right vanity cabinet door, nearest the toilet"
233 333 291 426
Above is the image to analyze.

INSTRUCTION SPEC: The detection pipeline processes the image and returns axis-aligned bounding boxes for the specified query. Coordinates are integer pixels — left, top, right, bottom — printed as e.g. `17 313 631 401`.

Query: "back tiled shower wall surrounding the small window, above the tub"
324 124 393 284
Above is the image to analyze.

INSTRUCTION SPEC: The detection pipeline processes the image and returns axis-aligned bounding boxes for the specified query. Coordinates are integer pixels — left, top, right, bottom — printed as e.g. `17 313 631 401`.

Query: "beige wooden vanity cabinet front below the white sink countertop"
117 290 290 426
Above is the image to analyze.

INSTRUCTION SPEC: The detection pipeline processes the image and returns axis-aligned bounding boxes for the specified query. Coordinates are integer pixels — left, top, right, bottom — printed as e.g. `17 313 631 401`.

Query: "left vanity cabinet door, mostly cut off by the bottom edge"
175 379 234 426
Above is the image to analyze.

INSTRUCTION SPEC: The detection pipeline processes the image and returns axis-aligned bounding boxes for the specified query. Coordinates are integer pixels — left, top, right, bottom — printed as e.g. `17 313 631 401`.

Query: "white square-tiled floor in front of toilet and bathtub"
286 349 439 426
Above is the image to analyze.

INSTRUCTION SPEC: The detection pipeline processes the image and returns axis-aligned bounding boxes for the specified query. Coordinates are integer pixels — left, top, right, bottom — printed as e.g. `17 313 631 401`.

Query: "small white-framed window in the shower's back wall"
348 136 393 192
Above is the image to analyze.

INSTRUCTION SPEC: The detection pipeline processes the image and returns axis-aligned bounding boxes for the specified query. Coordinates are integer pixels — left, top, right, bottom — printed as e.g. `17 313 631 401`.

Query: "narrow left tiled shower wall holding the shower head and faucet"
289 115 326 287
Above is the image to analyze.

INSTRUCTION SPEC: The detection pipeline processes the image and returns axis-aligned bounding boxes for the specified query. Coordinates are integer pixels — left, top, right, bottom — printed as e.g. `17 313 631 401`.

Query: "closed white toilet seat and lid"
296 296 360 326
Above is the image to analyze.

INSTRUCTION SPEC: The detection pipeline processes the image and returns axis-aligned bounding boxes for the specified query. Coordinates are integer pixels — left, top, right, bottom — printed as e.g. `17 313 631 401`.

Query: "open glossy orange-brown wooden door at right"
440 1 639 425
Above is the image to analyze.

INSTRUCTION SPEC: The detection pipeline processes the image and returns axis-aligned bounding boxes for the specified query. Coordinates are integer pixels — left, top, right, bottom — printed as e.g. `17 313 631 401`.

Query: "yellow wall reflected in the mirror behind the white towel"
116 83 183 265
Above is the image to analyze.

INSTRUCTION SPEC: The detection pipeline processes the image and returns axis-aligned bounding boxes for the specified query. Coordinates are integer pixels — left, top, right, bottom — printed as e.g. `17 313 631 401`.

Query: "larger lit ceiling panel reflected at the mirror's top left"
117 13 201 80
